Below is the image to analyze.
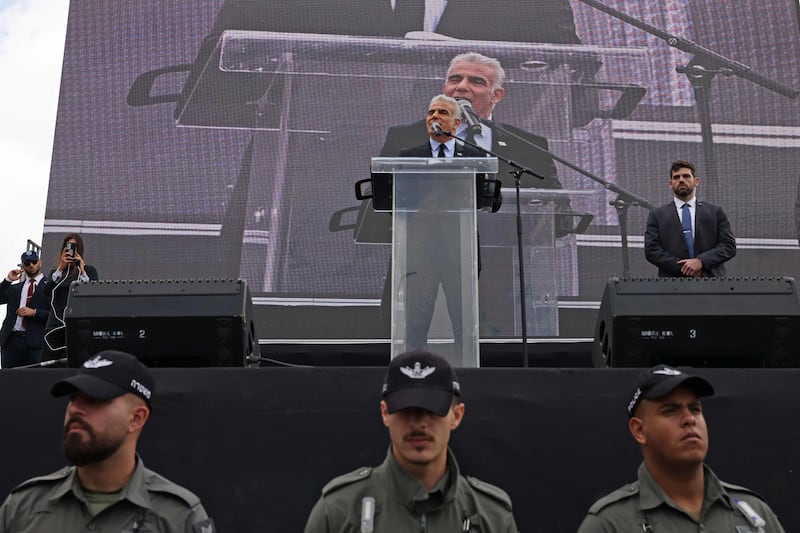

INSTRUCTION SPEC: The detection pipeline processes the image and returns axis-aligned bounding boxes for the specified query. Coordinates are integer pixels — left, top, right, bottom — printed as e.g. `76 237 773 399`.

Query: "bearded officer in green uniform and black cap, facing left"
0 350 215 533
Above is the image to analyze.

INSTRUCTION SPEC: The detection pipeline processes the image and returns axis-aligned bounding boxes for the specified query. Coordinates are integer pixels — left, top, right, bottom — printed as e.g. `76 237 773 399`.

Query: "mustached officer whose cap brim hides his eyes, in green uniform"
305 352 517 533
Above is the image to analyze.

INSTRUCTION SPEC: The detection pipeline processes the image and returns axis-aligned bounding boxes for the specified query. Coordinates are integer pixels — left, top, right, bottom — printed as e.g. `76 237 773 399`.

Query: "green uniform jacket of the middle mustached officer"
305 448 517 533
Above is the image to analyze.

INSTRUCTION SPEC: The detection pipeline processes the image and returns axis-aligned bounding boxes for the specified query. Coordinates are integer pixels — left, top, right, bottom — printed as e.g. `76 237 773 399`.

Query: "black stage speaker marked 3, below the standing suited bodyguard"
592 277 800 368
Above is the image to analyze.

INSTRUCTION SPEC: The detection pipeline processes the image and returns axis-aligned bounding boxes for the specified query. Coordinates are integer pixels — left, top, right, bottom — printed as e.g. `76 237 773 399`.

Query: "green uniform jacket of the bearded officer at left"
0 456 215 533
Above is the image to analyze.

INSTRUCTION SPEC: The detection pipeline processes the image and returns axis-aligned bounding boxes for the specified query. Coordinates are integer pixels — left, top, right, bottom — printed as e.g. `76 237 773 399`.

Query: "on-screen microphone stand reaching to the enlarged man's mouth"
462 108 655 278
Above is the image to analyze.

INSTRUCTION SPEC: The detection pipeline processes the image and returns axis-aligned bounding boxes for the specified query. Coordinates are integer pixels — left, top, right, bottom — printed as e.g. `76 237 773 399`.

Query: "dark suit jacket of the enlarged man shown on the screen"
380 118 563 189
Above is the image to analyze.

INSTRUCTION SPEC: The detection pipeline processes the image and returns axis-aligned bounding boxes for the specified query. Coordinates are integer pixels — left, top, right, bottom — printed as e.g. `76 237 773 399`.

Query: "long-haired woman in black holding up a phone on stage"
41 233 98 361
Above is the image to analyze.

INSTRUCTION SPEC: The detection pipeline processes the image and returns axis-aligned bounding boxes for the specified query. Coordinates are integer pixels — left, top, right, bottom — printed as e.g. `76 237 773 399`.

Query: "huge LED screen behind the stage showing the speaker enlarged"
44 0 800 340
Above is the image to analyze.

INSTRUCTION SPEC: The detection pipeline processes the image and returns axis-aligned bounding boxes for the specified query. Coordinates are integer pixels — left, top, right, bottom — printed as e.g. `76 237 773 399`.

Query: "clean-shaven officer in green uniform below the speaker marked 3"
578 365 783 533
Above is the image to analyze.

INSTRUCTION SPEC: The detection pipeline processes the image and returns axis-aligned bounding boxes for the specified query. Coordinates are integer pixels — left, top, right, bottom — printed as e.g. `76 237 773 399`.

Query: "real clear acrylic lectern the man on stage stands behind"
372 157 497 367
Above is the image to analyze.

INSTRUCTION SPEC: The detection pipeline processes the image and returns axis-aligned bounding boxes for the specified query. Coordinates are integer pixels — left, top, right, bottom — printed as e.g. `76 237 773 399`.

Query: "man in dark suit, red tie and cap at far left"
0 250 50 368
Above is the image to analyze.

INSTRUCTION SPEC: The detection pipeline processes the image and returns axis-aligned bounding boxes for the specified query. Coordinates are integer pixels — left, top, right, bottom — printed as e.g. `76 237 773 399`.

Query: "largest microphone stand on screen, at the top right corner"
580 0 800 197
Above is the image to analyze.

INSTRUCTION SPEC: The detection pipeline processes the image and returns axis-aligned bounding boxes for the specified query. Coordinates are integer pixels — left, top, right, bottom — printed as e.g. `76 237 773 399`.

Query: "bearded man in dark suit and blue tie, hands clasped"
644 160 736 277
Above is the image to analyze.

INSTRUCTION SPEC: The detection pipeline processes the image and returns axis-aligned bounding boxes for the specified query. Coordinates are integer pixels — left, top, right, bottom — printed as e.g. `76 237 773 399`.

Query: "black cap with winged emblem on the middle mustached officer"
382 351 461 416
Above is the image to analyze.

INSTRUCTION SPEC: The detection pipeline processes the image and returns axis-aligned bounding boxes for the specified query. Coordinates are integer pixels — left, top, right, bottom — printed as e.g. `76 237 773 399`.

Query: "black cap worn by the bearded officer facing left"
50 350 155 406
